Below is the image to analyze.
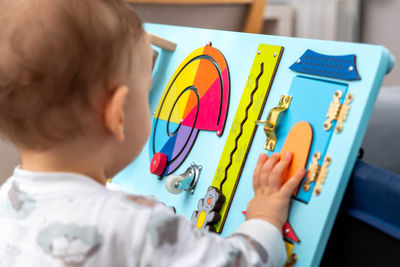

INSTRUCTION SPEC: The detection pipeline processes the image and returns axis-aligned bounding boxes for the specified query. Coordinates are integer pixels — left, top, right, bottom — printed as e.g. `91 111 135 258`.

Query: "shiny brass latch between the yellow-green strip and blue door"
255 95 292 151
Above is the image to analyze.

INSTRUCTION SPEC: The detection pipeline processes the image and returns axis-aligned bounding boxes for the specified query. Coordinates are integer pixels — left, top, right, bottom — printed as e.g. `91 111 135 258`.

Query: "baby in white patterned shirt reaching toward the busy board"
0 0 304 267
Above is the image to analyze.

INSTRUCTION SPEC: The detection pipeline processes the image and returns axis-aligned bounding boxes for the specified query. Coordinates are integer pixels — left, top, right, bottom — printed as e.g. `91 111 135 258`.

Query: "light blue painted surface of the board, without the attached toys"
113 24 394 266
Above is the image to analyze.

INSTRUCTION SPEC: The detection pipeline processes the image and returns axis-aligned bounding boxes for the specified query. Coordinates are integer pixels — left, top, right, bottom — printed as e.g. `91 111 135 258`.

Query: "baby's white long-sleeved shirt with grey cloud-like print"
0 168 286 267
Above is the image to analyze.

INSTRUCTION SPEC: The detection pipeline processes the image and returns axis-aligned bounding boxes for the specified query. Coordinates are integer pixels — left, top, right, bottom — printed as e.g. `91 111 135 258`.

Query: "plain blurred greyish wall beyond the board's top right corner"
361 0 400 86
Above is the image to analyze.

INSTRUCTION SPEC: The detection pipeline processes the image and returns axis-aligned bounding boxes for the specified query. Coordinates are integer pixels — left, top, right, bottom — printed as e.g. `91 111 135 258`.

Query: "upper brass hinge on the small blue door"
324 90 354 133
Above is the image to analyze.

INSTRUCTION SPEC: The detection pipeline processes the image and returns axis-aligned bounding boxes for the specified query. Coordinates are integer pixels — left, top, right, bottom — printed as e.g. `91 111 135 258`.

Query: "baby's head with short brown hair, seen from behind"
0 0 152 178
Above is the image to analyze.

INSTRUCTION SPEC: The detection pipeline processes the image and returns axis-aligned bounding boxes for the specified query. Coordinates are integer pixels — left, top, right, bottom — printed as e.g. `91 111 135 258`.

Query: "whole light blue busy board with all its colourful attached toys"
112 24 394 266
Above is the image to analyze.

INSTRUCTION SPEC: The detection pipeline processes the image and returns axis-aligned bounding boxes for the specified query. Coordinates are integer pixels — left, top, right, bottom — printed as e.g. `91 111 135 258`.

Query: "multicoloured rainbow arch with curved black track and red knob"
149 43 230 177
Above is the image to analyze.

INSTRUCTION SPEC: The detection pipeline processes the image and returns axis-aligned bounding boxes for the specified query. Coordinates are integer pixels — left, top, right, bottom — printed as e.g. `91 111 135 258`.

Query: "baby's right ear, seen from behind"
104 85 128 142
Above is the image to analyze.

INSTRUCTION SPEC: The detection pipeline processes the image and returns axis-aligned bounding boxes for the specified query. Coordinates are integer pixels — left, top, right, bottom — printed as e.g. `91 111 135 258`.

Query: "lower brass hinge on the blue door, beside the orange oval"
303 152 332 196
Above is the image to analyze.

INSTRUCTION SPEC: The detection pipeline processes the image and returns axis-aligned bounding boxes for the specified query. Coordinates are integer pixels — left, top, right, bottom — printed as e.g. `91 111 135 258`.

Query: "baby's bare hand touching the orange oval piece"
246 152 305 230
